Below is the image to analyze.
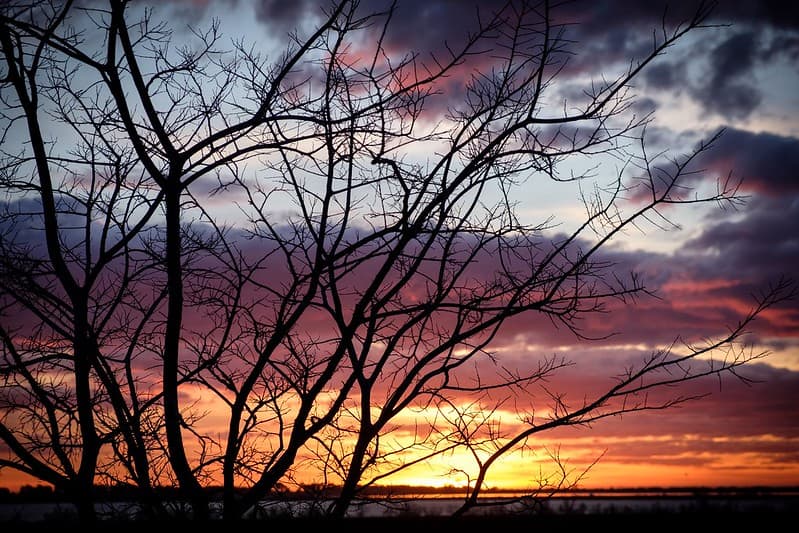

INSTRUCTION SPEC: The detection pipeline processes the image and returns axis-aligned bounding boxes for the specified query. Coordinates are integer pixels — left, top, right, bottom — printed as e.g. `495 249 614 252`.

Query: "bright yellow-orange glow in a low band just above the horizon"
0 435 799 491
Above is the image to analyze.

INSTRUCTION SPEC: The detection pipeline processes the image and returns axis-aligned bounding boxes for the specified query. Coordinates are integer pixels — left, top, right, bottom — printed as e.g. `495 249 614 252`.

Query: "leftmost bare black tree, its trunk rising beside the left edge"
0 3 174 517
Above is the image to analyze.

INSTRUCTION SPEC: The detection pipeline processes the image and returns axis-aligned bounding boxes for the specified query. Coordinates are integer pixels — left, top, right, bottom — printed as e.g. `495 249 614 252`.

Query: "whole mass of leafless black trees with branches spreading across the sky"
0 0 791 519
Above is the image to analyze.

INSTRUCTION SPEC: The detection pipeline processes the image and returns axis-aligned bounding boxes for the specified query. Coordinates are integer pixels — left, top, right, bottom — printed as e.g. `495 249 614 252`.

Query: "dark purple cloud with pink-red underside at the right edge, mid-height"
608 195 799 342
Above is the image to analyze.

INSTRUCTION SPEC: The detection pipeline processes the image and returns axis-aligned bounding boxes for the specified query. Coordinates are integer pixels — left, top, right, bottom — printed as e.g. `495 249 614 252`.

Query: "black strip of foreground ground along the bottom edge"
0 509 799 533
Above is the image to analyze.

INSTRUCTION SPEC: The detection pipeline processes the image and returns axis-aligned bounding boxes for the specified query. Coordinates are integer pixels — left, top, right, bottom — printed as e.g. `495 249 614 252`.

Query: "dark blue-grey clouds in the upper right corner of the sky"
540 1 799 119
